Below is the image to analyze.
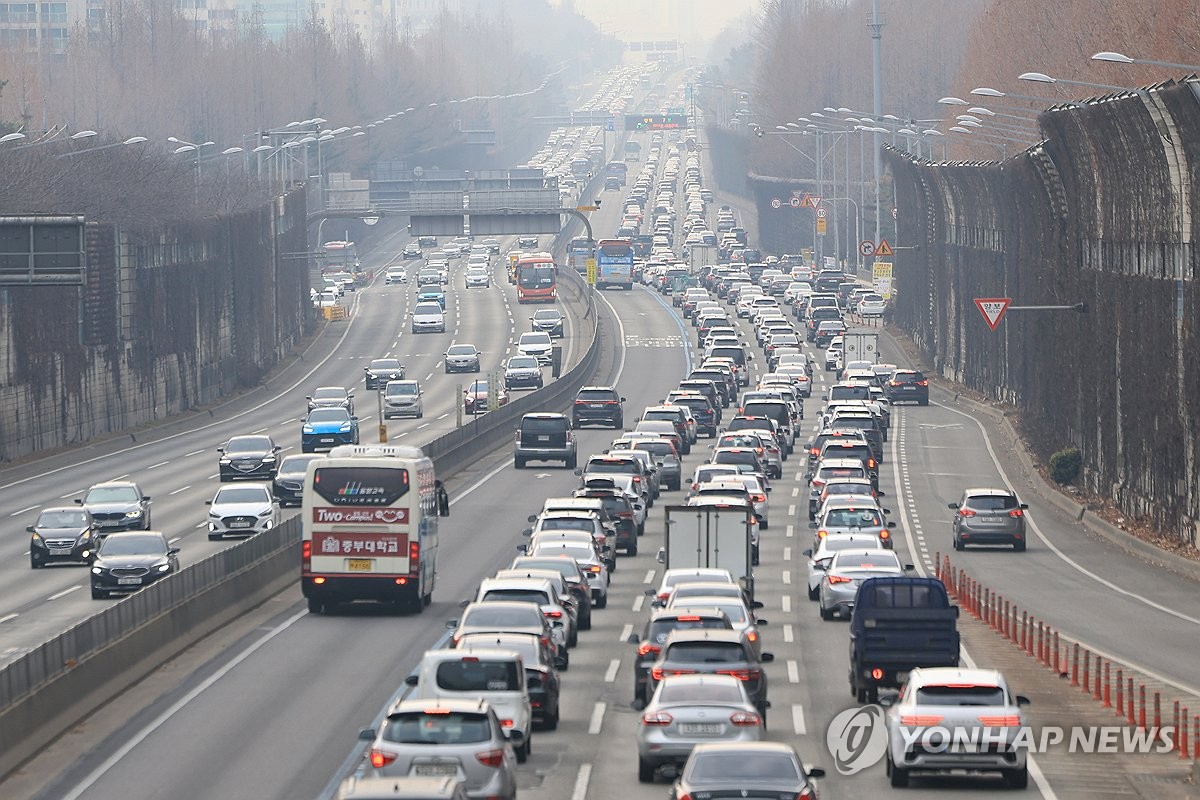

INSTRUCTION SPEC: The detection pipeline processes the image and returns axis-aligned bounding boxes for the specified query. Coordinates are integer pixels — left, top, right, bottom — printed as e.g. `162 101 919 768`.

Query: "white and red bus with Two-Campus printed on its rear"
300 445 450 614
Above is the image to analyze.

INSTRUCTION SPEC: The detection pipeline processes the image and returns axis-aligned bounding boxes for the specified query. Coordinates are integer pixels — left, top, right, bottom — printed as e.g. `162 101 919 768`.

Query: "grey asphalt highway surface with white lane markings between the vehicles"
0 101 1200 800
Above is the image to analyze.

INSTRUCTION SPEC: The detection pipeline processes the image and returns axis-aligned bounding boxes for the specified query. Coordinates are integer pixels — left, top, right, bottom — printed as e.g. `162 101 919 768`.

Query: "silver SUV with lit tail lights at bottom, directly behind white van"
359 698 517 800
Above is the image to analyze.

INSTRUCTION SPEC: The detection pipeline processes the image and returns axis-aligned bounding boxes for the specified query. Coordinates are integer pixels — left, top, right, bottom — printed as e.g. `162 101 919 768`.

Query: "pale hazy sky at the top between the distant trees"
558 0 758 43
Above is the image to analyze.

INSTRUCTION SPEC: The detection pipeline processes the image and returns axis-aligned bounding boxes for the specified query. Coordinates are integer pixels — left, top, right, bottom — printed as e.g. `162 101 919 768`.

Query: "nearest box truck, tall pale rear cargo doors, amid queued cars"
658 501 755 601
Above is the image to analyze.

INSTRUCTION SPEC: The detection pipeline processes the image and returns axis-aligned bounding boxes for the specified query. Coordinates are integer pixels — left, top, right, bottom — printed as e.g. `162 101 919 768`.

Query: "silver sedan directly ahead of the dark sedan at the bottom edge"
637 675 762 783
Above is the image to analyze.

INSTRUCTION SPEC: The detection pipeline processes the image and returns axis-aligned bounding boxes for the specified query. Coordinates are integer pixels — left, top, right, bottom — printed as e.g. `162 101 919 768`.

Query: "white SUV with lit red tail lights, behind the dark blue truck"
881 667 1030 789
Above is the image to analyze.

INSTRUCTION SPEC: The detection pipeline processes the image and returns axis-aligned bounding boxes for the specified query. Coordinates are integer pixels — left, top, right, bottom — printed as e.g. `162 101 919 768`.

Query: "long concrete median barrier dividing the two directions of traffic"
0 236 601 777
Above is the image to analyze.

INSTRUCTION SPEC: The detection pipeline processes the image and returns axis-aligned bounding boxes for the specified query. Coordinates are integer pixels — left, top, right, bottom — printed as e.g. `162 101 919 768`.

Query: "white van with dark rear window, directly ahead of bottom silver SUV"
404 648 533 762
